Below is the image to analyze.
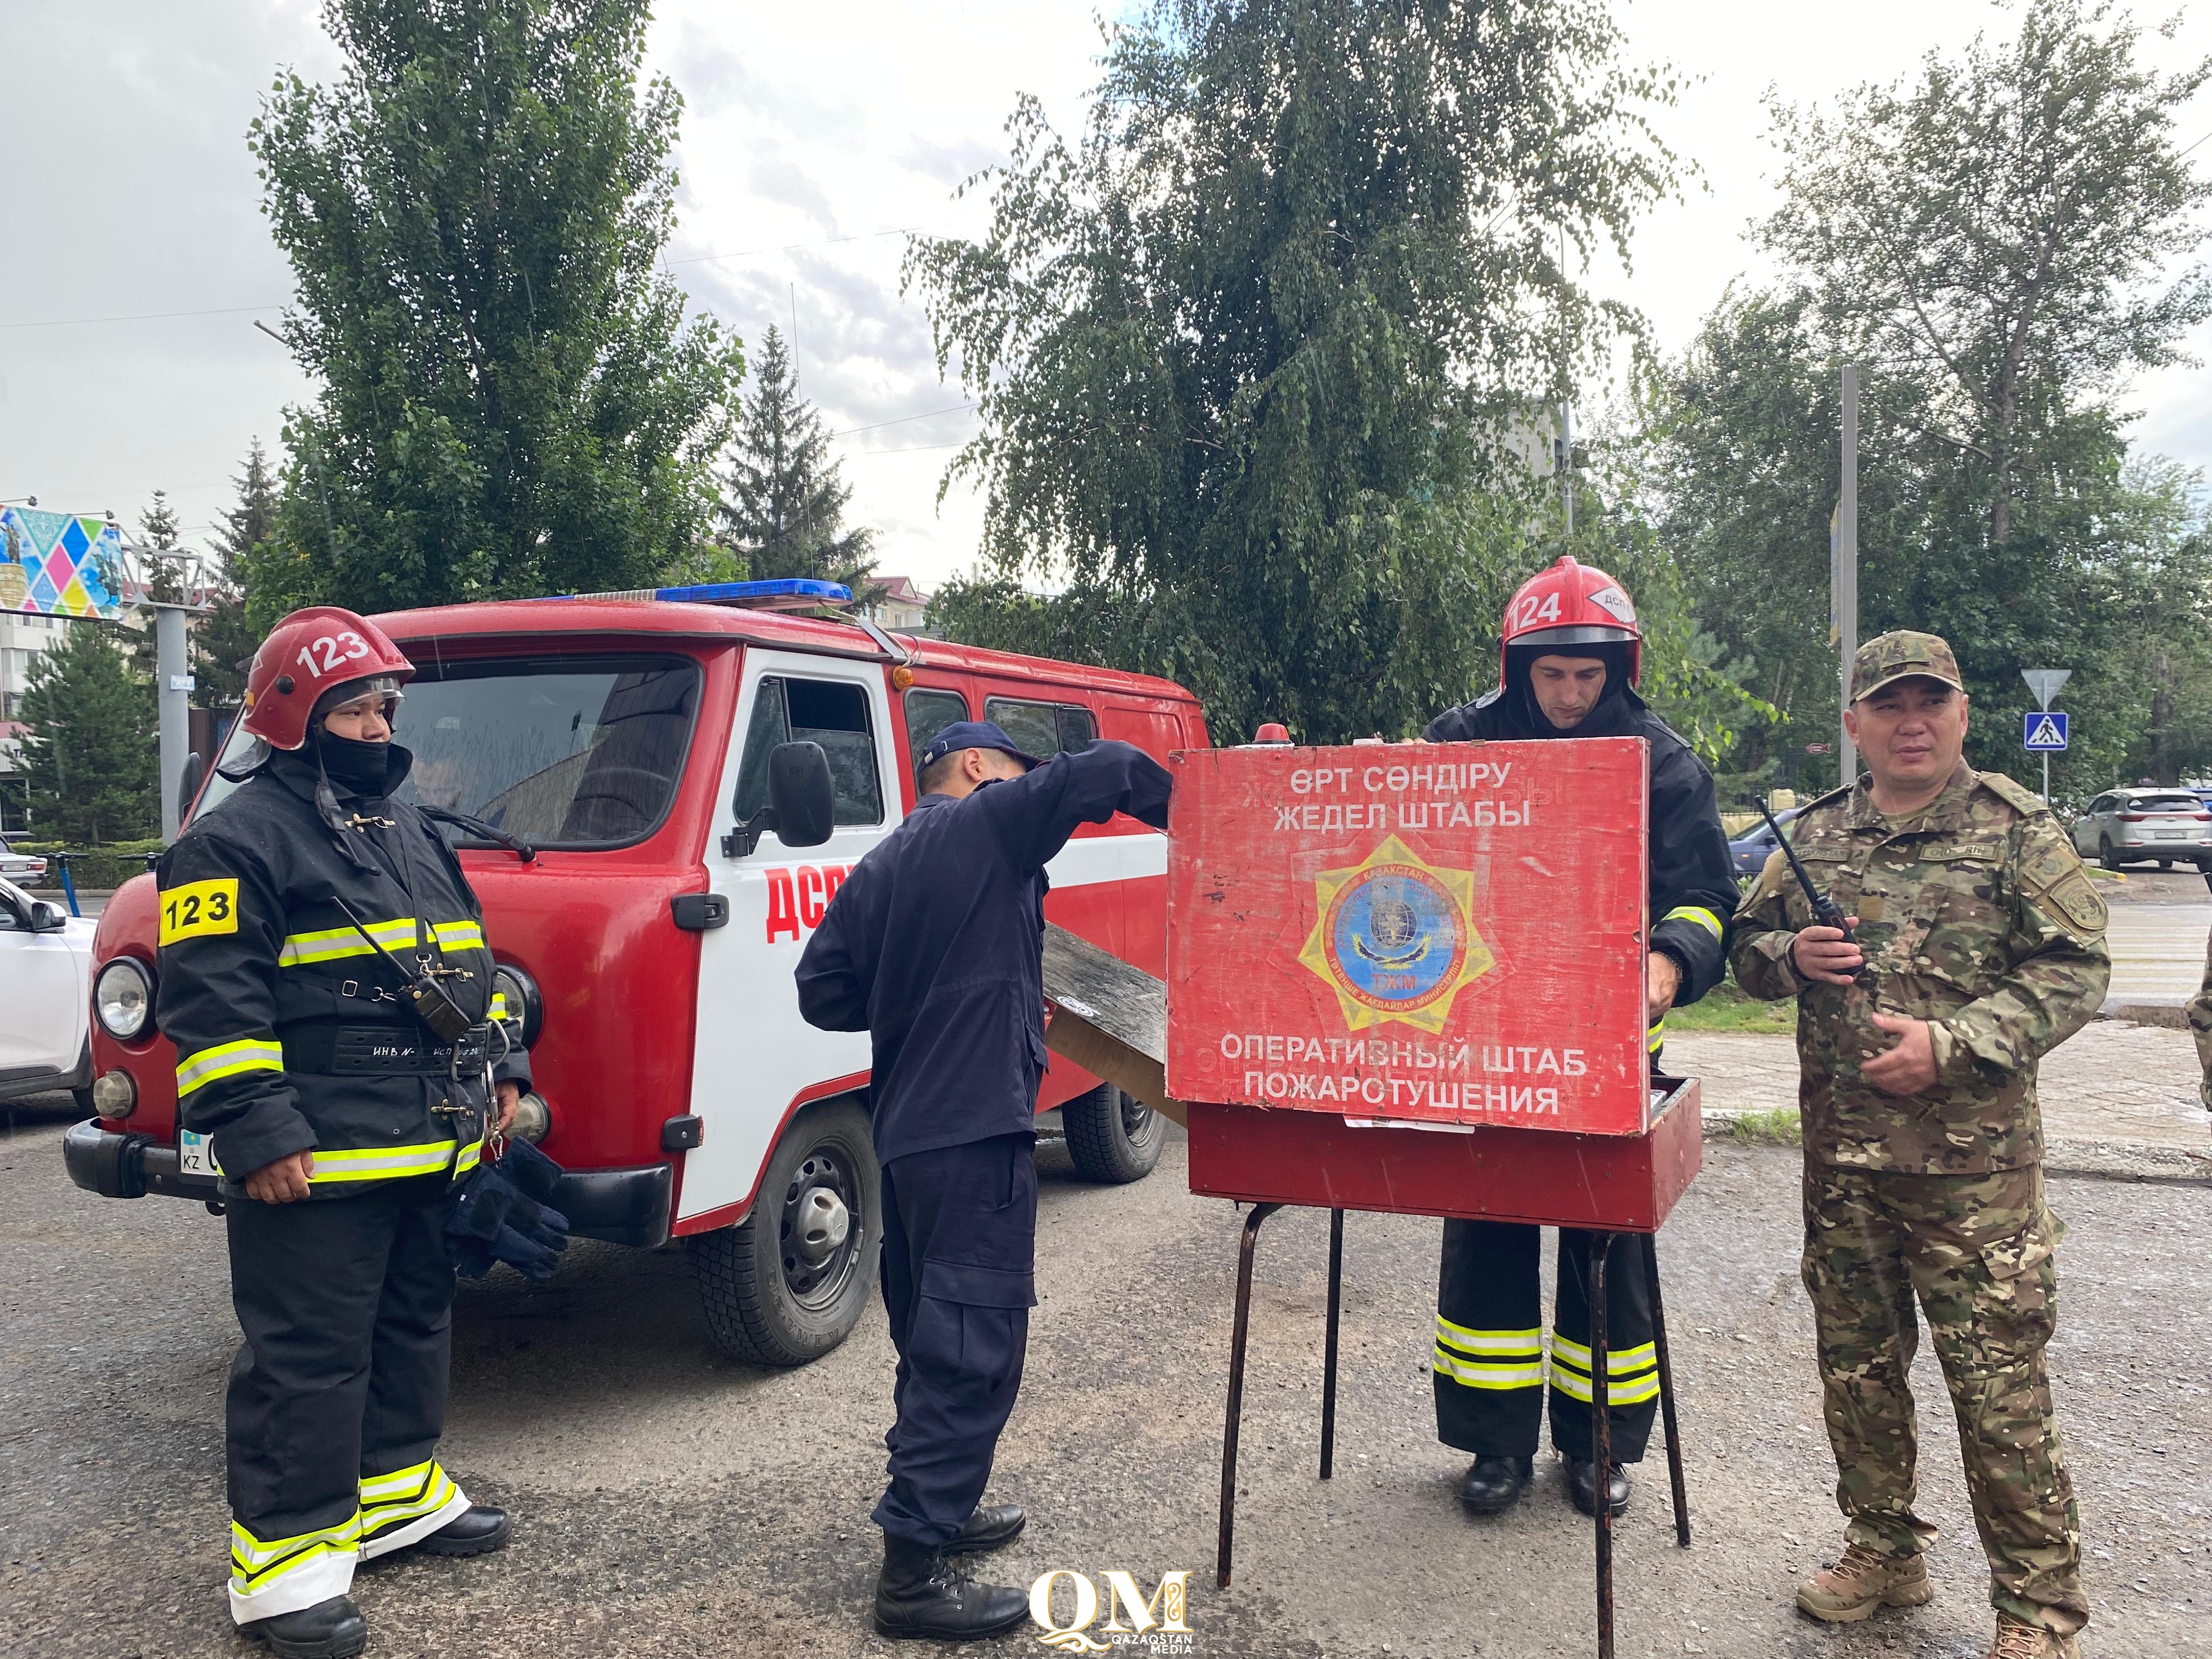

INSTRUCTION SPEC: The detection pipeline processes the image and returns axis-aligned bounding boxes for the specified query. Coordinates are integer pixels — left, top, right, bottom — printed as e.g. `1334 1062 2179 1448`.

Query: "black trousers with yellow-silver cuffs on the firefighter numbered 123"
225 1172 467 1621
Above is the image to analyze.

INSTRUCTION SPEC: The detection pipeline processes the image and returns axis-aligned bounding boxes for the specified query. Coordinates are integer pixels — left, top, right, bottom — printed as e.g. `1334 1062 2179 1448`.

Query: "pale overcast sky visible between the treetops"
0 0 2212 584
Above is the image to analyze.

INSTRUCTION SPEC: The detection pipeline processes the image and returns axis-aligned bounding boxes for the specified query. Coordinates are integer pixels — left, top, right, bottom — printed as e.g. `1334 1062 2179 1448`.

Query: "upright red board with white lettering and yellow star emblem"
1168 739 1650 1141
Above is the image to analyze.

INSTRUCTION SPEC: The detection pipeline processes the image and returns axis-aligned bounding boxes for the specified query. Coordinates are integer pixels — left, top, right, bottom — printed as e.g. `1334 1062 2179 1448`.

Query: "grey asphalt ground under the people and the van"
0 1092 2212 1659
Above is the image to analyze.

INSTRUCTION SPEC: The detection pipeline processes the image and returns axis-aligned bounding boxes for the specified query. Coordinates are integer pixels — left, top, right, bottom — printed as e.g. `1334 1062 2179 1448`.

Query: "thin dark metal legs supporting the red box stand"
1215 1203 1690 1659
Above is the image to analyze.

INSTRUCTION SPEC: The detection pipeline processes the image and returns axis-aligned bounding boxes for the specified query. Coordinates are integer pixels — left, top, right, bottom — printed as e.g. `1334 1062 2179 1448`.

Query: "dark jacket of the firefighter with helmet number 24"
1423 686 1736 1051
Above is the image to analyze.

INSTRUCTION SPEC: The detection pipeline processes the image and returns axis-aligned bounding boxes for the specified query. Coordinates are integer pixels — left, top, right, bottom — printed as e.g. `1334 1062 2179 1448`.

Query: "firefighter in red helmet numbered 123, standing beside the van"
155 606 529 1659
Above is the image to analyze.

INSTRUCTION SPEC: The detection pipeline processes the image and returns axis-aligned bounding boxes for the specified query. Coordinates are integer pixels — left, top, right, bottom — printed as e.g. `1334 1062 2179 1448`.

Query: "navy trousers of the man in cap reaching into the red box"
874 1135 1037 1544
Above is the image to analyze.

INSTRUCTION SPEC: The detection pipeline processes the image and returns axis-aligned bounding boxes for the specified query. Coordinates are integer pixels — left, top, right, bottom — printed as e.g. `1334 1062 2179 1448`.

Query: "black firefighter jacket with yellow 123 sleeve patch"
155 748 529 1199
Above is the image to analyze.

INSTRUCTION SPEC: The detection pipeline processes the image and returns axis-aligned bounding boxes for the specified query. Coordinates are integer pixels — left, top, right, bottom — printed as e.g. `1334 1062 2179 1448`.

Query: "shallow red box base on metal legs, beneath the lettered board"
1190 1080 1703 1232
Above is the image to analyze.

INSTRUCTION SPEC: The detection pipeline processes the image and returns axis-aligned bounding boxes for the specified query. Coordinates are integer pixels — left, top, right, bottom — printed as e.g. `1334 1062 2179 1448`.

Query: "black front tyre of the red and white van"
690 1097 883 1365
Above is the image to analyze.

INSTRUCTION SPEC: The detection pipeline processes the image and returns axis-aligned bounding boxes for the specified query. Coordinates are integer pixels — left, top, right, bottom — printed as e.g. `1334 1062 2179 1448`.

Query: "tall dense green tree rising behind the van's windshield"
241 0 743 626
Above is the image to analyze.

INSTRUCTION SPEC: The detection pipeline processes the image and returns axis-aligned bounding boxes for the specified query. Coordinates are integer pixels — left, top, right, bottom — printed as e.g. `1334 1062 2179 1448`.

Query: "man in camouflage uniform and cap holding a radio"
1730 633 2111 1659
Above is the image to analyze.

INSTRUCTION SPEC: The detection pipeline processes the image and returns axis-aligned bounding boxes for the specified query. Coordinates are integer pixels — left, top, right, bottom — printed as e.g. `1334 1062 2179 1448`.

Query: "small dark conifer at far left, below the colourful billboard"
22 622 161 845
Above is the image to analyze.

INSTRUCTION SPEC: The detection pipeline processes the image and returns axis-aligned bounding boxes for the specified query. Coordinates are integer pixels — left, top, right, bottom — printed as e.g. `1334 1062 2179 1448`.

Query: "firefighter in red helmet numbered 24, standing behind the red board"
1423 557 1736 1515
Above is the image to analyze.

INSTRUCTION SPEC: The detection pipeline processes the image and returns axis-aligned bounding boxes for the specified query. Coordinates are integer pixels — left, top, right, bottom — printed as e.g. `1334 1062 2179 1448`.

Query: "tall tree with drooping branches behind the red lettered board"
907 0 1674 741
